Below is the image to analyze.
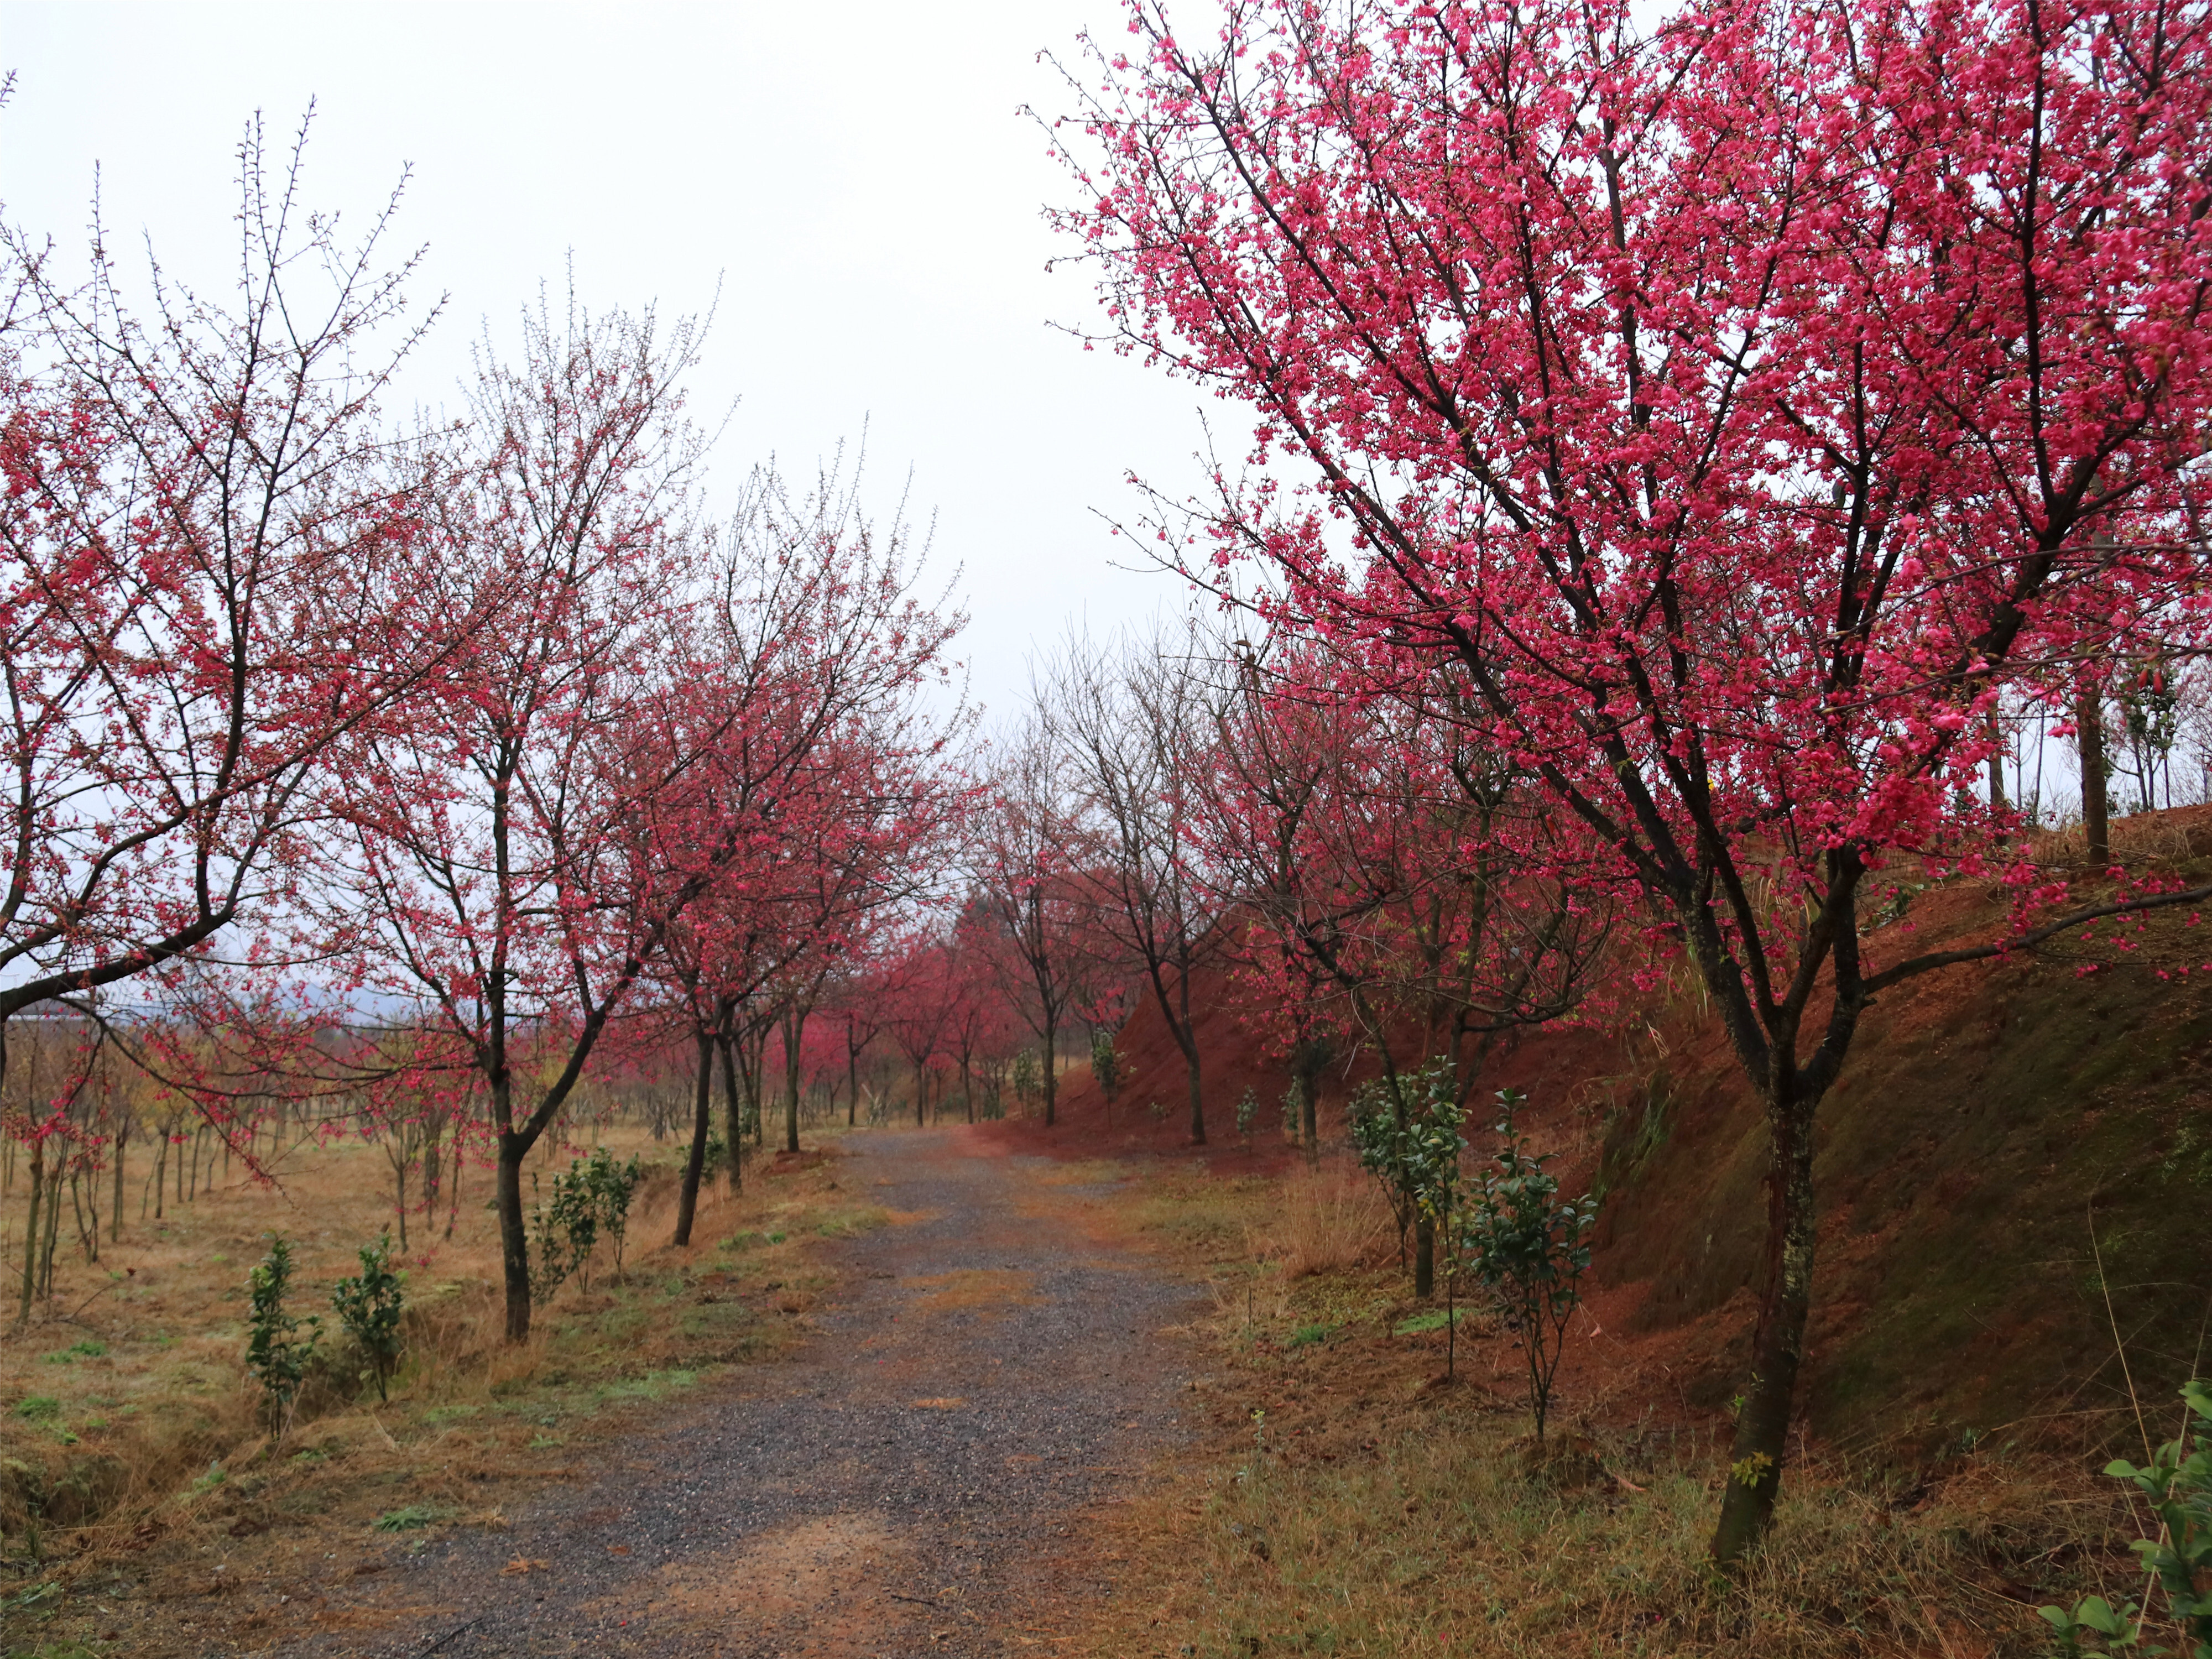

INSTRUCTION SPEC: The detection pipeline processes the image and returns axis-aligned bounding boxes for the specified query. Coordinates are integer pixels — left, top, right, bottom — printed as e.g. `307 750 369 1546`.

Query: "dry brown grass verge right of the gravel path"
1071 1175 2139 1659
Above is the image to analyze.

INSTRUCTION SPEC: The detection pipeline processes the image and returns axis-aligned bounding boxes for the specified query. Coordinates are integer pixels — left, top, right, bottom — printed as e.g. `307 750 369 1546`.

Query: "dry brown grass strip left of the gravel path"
0 1128 885 1595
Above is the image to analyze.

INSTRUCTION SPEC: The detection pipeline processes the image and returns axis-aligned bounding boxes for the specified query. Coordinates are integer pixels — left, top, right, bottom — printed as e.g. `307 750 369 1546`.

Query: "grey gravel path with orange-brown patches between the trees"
290 1130 1192 1659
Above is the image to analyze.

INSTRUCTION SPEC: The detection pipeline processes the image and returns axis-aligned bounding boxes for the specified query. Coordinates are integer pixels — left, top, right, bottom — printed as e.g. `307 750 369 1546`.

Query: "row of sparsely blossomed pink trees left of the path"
0 131 958 1340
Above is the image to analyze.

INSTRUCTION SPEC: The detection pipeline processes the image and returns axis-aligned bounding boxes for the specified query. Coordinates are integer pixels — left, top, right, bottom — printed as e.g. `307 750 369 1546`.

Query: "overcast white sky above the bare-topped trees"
0 0 1199 714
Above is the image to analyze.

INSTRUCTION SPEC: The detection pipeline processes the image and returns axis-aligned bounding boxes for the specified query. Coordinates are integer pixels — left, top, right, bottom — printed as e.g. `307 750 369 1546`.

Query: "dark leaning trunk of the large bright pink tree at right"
1712 1079 1818 1568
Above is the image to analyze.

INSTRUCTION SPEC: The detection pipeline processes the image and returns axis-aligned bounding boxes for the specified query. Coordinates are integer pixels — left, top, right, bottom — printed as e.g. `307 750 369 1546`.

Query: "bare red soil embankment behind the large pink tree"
991 807 2212 1447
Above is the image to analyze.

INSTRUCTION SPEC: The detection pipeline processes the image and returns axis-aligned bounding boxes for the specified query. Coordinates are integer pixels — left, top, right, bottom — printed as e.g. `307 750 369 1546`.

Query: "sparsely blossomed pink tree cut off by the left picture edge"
0 111 467 1186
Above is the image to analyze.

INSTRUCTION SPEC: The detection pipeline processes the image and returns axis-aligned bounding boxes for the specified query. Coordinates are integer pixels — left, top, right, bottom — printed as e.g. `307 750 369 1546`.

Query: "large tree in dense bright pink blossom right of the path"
1066 0 2212 1564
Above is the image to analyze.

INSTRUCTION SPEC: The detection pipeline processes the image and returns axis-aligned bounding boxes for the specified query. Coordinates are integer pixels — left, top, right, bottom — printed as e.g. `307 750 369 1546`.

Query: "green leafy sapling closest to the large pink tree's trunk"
1455 1088 1597 1444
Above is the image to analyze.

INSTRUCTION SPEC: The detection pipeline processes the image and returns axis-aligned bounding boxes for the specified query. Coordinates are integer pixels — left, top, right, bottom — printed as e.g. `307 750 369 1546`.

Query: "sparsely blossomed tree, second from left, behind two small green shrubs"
327 292 743 1340
